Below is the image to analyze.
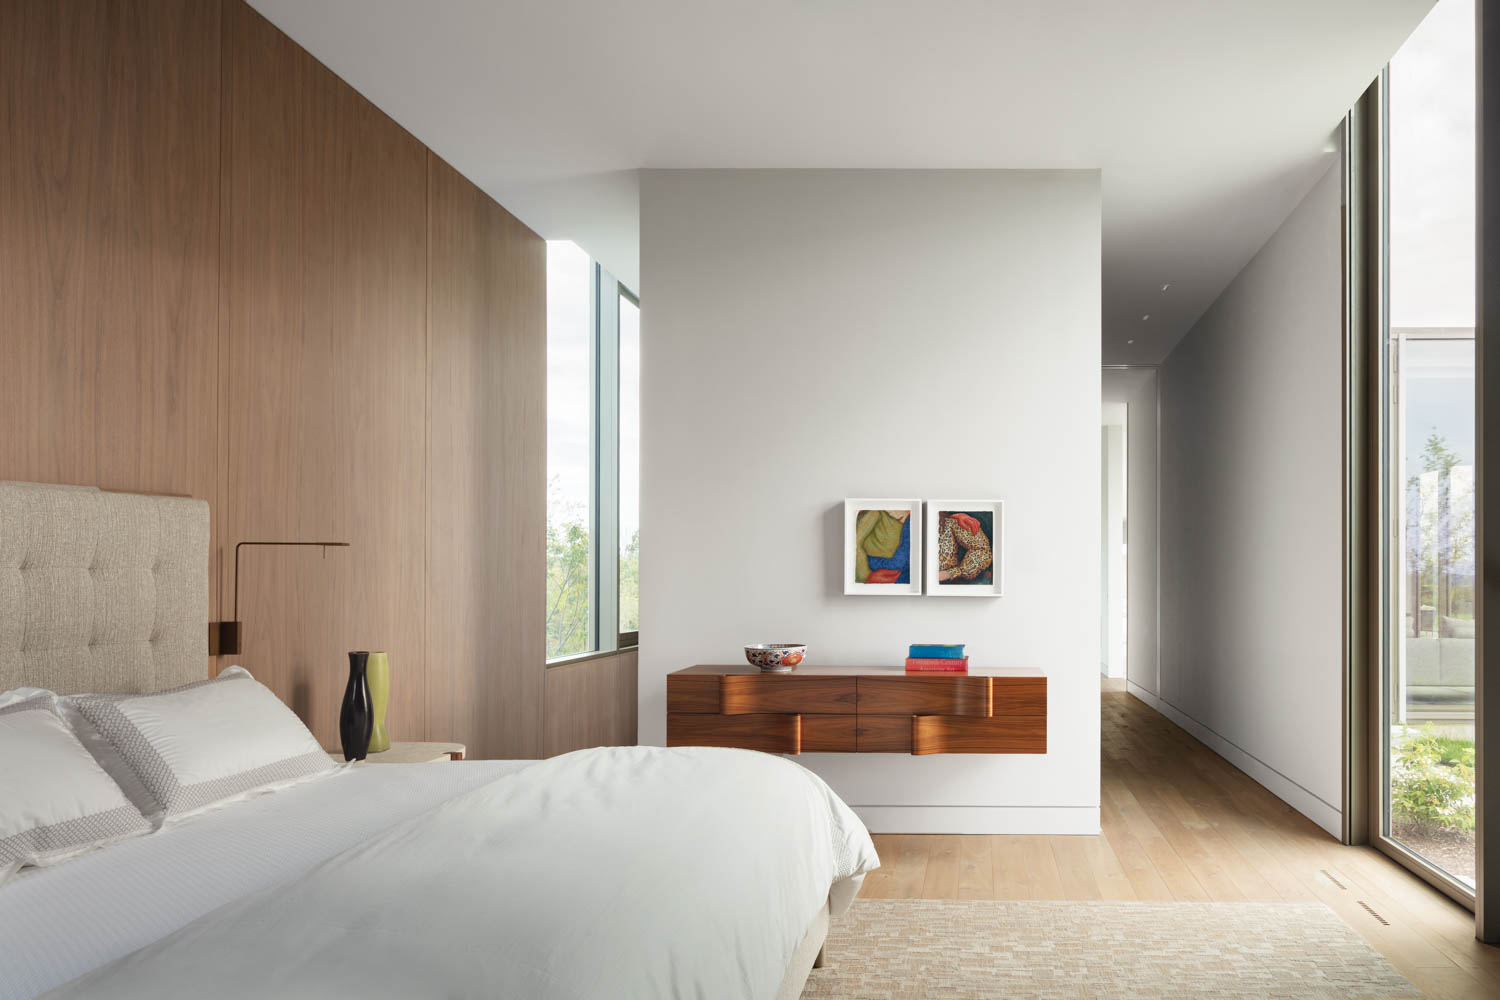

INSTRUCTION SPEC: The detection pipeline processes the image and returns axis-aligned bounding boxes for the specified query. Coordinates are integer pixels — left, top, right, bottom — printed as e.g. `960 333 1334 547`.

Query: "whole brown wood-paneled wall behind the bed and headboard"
0 0 591 757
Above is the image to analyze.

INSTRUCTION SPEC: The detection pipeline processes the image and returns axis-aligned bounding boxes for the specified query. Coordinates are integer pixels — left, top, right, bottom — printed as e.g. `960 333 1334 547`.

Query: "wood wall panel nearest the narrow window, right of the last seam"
426 153 549 759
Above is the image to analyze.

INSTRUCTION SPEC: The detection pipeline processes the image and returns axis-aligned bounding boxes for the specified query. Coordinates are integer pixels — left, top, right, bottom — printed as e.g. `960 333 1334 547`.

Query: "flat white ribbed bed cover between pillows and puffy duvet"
0 760 537 1000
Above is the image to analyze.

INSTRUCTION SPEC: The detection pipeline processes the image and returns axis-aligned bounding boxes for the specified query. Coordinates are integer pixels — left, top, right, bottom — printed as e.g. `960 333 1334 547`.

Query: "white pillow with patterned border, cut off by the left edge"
0 693 152 879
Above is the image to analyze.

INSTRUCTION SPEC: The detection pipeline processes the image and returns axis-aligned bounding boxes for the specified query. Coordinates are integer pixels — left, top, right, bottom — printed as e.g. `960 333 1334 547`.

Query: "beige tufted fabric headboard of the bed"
0 481 209 694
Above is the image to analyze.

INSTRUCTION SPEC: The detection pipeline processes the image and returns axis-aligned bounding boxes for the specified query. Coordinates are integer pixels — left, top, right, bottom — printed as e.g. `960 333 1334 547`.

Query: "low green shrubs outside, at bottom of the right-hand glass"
1391 726 1475 834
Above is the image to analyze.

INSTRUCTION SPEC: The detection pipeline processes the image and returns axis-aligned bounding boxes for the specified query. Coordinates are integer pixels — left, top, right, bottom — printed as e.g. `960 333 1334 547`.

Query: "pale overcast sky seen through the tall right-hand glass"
1389 0 1475 327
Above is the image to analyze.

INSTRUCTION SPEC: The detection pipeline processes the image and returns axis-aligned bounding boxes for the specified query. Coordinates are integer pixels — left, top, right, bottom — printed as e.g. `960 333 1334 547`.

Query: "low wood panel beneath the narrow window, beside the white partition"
543 649 638 757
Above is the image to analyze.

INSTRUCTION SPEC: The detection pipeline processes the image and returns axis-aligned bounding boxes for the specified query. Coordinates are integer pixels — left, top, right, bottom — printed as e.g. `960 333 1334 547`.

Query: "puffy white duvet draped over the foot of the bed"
48 747 879 1000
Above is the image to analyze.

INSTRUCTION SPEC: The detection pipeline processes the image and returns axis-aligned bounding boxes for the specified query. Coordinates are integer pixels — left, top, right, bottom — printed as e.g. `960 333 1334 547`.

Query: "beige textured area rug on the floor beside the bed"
803 900 1421 1000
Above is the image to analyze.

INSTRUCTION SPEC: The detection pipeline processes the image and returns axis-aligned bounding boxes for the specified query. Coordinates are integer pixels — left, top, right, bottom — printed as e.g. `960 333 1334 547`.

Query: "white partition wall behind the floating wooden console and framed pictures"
641 171 1100 832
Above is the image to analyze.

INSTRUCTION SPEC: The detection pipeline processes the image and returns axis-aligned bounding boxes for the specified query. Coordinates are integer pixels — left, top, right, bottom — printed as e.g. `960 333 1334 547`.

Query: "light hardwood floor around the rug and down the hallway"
860 691 1500 1000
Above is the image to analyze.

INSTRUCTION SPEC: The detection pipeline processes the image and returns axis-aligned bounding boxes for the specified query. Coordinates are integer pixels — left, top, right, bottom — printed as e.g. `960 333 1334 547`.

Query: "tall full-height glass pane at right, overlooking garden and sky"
1377 0 1476 900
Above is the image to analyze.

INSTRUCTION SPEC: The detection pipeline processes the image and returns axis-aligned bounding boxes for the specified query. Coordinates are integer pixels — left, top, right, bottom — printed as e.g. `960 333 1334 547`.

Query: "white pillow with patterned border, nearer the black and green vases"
72 667 339 820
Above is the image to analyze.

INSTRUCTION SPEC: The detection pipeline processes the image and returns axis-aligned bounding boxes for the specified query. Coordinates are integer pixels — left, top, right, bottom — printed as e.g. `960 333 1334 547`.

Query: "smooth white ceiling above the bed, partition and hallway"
251 0 1433 364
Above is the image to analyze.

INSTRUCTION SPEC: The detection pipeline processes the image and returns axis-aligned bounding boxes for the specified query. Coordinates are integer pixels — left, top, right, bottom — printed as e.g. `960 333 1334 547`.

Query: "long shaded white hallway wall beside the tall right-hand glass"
1152 162 1343 835
